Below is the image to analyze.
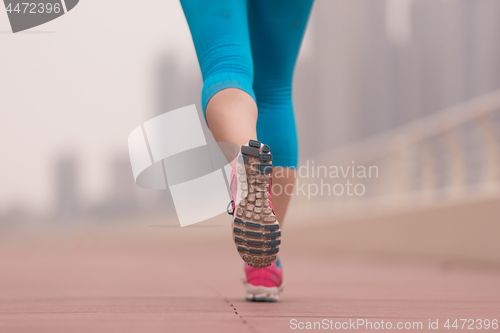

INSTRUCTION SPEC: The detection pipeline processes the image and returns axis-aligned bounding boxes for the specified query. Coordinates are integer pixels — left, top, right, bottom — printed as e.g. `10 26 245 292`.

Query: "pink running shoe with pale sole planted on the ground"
243 258 284 302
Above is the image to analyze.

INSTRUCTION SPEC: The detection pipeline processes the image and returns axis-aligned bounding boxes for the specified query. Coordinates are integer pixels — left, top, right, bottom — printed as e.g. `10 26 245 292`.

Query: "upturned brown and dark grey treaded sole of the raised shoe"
233 140 281 268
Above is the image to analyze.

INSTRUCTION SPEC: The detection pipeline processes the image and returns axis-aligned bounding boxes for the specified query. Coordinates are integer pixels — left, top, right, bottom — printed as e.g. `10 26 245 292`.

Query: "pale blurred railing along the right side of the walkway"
299 90 500 208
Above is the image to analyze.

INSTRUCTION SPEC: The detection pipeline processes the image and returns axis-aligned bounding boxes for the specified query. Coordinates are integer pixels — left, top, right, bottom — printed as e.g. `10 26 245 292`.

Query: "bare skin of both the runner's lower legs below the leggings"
206 88 296 227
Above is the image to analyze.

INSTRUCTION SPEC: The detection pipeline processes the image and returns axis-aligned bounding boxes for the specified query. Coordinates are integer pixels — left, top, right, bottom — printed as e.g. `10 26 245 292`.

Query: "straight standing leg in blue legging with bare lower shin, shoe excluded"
248 0 313 224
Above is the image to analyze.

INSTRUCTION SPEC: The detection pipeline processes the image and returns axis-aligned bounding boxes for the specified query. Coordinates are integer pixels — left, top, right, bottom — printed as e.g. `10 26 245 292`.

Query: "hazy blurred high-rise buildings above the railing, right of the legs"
294 0 500 158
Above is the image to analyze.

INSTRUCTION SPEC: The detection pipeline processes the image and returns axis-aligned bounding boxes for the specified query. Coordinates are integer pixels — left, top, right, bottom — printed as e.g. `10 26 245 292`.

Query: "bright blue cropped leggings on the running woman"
181 0 313 168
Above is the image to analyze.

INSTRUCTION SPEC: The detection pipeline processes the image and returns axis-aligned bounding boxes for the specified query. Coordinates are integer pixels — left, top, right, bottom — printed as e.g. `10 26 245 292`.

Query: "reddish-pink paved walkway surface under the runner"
0 218 500 333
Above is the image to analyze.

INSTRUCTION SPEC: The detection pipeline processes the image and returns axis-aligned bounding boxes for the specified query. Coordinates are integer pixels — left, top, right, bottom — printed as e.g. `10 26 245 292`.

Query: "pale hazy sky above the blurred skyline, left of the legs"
0 0 308 212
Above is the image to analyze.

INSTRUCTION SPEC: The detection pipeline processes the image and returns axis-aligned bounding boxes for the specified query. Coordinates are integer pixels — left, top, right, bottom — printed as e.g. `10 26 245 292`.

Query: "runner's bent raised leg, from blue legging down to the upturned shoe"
181 0 281 270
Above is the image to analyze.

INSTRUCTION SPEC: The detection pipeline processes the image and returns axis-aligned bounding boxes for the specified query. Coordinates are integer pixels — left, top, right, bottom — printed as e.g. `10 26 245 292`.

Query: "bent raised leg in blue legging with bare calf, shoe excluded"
181 0 257 146
